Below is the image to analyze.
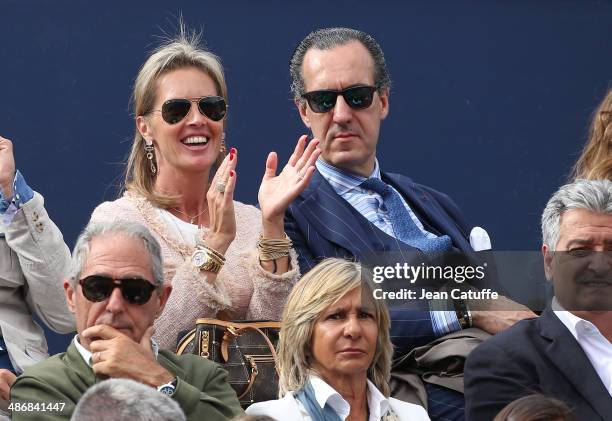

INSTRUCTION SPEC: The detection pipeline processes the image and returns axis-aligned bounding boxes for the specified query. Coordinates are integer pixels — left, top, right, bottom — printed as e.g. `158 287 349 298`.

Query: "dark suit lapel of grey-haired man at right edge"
540 309 612 419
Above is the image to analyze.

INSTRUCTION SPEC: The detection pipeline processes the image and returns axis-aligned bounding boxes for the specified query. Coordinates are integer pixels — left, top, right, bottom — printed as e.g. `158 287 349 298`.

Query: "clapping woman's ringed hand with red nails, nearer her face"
206 148 238 254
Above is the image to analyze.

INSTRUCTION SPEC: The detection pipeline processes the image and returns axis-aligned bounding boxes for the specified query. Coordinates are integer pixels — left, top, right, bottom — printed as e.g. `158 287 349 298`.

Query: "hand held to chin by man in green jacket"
81 325 174 386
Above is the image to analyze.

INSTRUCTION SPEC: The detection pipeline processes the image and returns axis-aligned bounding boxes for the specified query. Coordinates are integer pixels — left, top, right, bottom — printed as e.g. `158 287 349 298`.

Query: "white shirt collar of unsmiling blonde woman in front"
298 374 389 421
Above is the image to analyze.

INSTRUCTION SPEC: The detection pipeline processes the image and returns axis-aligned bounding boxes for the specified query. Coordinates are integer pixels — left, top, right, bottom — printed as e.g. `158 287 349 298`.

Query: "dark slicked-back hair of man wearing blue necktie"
289 28 391 103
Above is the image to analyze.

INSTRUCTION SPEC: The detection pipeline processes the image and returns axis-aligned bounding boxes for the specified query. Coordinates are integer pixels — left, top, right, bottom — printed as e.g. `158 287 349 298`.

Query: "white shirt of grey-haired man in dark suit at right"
552 297 612 396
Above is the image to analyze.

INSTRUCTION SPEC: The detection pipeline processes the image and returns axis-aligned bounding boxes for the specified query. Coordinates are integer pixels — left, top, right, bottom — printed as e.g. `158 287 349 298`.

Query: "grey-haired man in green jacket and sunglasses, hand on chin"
10 221 242 421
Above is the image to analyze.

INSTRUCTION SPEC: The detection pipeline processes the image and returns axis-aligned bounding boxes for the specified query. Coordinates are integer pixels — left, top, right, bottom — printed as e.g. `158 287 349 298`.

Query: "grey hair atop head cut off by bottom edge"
70 379 186 421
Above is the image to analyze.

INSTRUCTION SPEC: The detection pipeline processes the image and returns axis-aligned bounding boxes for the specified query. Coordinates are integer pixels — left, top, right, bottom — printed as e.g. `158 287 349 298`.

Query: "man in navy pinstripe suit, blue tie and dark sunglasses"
285 28 533 419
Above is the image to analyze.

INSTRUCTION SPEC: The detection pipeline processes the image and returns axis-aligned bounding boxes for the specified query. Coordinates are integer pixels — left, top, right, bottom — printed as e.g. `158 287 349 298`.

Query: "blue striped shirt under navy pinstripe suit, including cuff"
315 158 461 336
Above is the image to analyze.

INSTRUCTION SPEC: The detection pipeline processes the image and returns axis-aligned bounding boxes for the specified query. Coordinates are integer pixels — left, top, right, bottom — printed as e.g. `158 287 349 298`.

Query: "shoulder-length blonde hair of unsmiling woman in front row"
278 258 393 397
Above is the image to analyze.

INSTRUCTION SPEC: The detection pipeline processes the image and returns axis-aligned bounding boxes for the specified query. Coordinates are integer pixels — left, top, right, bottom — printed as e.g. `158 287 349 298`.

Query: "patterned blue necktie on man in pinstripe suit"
361 178 452 257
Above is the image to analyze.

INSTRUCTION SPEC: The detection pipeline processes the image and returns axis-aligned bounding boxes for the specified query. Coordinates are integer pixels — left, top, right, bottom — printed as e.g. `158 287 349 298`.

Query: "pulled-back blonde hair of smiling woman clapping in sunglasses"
123 22 227 207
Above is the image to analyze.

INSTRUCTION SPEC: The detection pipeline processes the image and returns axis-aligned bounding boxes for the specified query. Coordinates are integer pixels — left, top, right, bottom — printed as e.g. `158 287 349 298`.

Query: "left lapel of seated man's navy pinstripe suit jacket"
299 171 396 256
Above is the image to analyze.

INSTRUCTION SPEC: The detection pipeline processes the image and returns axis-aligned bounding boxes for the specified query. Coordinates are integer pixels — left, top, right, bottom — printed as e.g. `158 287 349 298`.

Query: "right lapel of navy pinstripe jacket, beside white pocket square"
382 173 472 252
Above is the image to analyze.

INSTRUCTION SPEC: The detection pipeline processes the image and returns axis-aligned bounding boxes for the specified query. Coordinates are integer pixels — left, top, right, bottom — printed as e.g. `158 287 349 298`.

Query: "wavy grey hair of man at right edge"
542 180 612 250
